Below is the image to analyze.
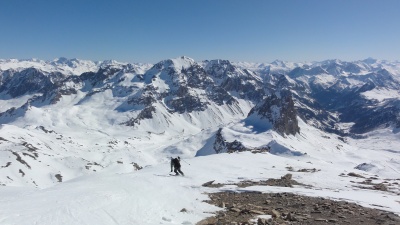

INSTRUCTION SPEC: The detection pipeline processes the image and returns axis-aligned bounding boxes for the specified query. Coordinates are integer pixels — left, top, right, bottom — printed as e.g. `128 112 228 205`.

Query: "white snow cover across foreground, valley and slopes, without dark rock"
0 57 400 225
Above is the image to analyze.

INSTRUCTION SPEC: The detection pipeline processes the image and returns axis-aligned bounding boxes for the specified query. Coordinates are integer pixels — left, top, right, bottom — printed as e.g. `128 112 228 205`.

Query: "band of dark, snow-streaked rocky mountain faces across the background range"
0 57 400 136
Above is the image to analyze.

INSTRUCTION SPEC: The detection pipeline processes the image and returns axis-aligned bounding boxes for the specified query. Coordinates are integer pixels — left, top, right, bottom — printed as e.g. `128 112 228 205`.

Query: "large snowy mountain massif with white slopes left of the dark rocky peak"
0 57 252 187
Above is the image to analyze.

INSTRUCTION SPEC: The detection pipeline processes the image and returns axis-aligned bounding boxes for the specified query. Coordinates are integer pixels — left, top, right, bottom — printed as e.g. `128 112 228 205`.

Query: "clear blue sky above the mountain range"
0 0 400 63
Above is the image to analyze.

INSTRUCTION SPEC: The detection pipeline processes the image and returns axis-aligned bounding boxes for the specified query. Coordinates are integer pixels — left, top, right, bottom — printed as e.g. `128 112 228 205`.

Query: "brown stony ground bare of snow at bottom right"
197 174 400 225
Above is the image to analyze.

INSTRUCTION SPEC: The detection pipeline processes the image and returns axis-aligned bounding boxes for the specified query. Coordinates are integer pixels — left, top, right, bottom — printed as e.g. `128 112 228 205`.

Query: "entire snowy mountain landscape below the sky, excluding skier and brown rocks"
0 57 400 224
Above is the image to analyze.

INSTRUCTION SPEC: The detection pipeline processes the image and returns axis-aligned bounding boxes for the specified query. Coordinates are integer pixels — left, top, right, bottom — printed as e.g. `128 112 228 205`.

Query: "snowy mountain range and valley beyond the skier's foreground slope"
0 56 400 224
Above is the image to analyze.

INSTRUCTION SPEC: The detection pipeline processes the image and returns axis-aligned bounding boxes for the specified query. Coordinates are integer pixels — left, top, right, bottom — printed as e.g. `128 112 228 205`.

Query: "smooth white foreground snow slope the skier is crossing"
0 145 400 225
